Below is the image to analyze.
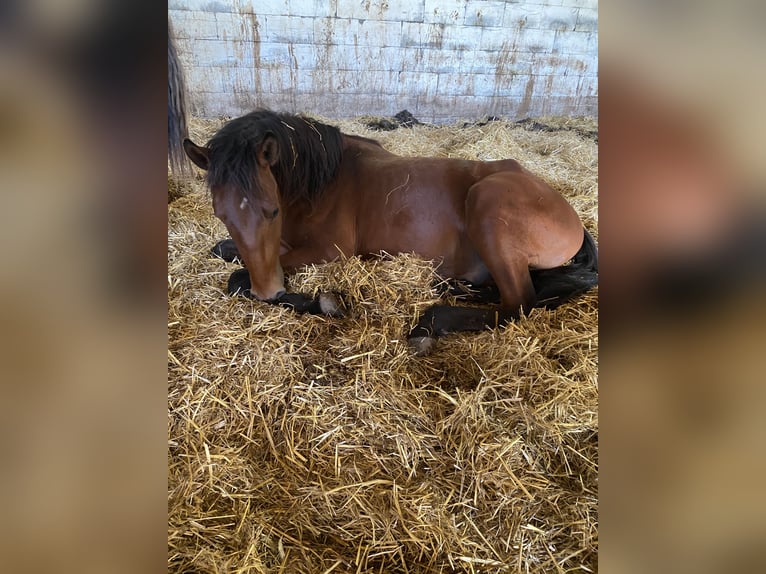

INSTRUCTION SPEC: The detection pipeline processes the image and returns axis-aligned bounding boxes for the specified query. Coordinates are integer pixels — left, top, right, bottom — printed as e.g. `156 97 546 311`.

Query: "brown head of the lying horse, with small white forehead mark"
184 138 285 301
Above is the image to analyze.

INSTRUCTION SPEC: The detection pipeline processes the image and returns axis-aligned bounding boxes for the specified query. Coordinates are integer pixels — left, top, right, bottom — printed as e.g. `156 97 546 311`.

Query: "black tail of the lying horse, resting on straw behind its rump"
531 229 598 309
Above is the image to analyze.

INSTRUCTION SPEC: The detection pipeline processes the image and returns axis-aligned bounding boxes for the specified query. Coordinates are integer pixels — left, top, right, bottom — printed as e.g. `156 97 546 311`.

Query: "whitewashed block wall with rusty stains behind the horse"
168 0 598 123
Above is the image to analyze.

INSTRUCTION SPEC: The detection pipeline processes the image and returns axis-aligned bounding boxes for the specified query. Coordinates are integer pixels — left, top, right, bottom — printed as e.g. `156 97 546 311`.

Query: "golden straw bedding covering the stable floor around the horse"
168 113 598 573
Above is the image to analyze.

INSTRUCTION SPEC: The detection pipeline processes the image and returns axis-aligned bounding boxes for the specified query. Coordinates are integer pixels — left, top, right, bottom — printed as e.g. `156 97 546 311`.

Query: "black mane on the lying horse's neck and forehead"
207 110 343 204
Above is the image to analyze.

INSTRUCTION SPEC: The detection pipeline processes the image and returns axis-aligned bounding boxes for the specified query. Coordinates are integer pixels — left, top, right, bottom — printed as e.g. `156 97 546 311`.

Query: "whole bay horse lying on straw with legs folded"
184 110 598 354
